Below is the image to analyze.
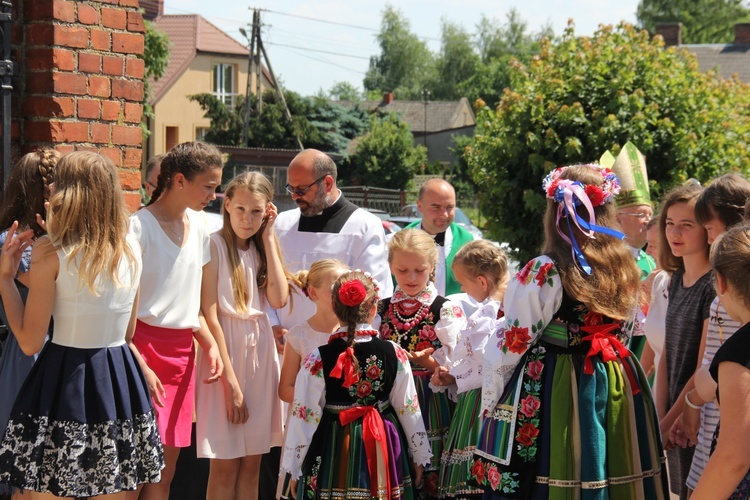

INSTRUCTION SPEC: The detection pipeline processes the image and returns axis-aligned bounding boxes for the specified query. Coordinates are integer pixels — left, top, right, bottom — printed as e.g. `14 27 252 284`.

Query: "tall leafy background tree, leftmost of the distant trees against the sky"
364 5 435 99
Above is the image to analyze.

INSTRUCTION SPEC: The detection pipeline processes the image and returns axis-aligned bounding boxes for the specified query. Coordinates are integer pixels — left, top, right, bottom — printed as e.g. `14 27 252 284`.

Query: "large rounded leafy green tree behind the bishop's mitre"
465 20 750 258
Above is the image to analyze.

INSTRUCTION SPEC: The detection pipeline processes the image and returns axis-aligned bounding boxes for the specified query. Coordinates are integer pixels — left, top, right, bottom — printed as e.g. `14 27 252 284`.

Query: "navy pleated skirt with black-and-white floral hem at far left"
0 342 164 497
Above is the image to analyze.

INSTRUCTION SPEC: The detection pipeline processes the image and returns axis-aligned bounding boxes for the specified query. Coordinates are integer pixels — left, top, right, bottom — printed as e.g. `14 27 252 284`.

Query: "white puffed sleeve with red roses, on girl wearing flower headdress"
482 256 563 414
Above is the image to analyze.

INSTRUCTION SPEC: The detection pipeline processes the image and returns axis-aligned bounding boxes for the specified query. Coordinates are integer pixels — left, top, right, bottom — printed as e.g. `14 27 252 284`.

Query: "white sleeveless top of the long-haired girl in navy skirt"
51 236 142 349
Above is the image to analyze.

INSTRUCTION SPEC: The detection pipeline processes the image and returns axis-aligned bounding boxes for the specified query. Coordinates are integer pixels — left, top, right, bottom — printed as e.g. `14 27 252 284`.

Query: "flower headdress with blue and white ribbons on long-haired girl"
542 164 625 274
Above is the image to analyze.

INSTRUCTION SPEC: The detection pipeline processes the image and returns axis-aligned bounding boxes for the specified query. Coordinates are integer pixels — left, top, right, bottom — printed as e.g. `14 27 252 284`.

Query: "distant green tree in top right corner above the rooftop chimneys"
636 0 750 43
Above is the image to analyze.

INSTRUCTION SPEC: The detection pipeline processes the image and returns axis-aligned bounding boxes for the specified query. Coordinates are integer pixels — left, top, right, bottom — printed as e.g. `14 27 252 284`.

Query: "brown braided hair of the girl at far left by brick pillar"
0 148 62 238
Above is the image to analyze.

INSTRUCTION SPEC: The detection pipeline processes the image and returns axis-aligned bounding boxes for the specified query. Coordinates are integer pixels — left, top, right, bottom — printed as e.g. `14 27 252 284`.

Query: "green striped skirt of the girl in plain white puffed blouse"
438 389 483 498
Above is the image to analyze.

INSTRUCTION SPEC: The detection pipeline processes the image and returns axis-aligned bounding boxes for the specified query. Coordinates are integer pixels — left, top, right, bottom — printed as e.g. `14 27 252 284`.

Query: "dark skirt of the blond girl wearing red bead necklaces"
412 367 456 498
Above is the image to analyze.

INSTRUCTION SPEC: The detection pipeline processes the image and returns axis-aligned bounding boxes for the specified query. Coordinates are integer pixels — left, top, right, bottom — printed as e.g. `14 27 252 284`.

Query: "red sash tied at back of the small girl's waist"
339 406 391 499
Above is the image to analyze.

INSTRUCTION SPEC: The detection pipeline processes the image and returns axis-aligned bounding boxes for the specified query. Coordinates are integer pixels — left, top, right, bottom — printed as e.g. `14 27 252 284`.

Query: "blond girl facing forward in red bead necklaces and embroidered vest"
378 229 466 497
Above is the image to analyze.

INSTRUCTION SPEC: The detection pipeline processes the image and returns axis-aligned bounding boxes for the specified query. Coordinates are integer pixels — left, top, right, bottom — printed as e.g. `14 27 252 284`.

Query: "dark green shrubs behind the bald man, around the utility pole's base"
188 90 368 153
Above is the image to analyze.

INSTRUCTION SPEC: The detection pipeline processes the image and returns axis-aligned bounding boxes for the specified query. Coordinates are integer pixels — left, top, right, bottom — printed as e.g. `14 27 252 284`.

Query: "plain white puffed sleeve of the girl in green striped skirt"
448 301 505 395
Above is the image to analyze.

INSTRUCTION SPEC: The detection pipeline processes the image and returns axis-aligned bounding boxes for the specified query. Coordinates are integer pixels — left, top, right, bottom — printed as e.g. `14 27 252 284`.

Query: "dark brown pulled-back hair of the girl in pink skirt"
148 141 223 205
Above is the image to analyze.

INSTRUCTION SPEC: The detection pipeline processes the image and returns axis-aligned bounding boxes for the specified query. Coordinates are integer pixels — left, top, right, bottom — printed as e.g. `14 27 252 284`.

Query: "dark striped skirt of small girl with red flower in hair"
296 406 416 500
